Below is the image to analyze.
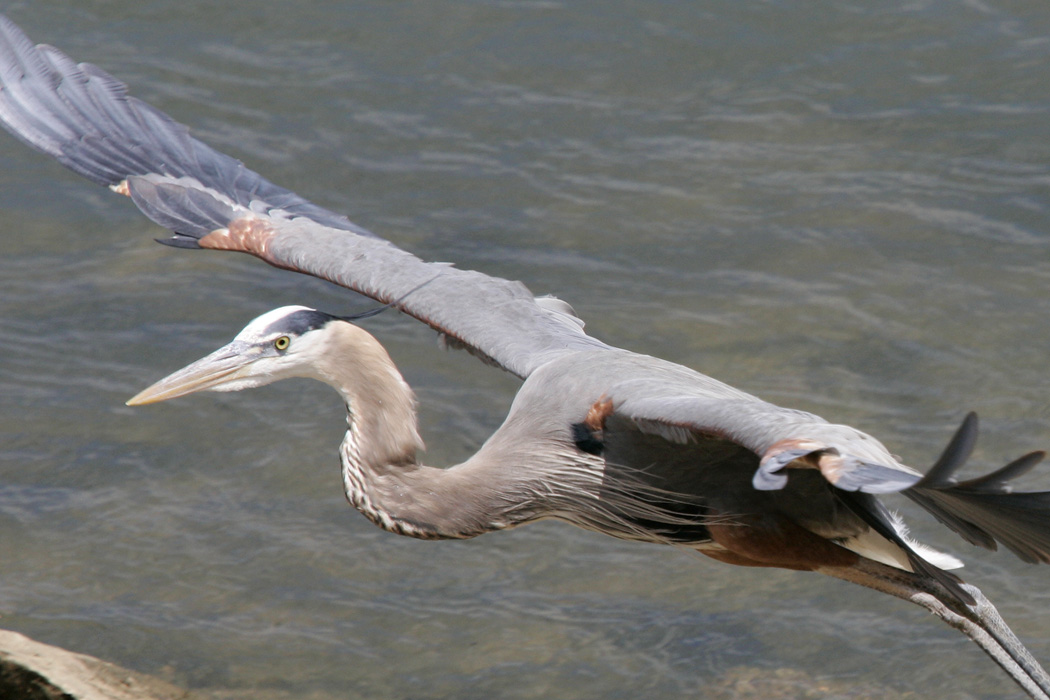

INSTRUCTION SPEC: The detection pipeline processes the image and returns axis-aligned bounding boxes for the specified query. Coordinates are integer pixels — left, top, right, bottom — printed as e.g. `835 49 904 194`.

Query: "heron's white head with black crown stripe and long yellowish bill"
127 306 341 406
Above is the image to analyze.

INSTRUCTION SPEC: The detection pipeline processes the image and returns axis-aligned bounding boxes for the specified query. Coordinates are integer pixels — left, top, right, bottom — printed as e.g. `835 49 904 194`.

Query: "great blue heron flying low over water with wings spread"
0 12 1050 699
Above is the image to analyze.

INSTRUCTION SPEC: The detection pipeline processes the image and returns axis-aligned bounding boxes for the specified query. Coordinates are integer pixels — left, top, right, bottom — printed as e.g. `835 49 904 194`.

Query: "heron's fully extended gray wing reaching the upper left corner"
0 17 606 377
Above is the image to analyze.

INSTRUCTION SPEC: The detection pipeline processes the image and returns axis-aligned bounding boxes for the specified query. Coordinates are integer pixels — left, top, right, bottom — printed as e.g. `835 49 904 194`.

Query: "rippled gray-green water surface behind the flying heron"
0 0 1050 699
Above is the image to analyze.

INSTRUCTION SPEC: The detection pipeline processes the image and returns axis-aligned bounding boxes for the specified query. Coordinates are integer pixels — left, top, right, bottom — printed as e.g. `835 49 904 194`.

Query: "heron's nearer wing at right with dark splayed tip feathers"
610 388 1050 569
